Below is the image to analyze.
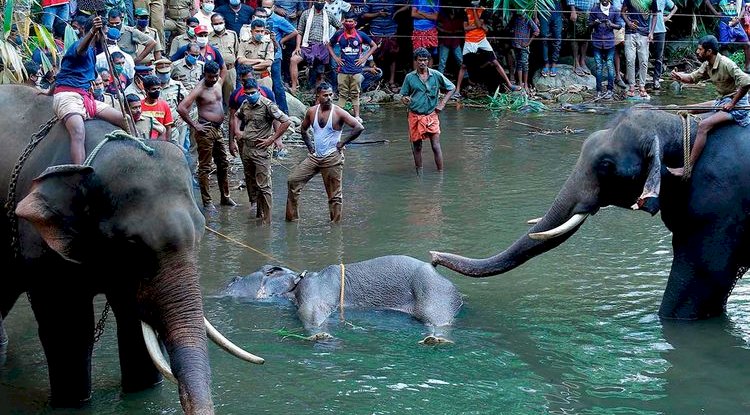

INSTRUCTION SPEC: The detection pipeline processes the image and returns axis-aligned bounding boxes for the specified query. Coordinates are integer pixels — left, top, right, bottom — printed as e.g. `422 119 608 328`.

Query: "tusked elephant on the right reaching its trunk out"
431 107 750 319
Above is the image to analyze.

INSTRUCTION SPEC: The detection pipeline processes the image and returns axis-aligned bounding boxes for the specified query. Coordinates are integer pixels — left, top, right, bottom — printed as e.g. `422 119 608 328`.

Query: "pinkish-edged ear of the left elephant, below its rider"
16 164 94 263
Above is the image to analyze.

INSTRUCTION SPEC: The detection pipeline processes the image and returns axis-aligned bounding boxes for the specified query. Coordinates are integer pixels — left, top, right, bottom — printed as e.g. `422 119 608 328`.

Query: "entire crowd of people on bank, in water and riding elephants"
10 0 750 222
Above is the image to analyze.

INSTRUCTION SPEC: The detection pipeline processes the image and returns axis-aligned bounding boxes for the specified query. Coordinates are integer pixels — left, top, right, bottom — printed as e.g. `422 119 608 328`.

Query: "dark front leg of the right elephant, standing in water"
659 223 742 320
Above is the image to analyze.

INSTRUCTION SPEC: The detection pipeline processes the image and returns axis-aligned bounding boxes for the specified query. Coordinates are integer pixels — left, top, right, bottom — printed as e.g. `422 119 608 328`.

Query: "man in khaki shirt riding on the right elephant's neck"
668 35 750 176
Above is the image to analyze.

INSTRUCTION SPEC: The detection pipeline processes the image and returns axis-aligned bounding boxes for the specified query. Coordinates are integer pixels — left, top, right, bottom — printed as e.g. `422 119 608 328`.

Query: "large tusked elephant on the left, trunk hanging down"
0 86 262 414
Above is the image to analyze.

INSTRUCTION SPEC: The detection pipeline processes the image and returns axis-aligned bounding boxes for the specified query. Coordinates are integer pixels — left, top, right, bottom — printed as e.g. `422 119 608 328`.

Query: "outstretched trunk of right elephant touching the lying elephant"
430 169 597 278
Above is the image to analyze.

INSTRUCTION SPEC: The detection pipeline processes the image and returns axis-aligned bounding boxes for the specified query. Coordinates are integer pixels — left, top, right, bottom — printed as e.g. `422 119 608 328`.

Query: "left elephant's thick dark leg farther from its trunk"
30 287 94 407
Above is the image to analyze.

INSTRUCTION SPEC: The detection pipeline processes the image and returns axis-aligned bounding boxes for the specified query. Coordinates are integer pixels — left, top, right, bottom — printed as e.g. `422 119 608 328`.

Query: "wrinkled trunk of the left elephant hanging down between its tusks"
141 253 214 414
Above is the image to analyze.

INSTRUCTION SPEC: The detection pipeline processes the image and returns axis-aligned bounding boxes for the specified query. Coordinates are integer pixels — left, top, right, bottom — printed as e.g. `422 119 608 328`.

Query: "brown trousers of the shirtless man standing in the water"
194 126 229 205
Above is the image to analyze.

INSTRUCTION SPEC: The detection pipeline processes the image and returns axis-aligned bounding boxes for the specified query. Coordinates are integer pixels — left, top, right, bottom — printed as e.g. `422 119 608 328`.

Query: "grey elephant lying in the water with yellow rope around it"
220 255 463 344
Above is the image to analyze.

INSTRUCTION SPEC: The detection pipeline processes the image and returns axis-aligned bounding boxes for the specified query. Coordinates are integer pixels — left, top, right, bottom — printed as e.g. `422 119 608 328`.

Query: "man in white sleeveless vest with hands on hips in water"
286 82 366 223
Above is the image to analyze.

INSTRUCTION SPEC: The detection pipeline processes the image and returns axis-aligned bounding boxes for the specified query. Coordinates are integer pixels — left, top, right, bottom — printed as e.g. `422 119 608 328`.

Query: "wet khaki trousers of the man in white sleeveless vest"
286 151 344 222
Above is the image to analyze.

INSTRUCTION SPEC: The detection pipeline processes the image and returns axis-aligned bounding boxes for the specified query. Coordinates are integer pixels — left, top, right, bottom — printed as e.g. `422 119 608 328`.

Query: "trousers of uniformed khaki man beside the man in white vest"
238 139 273 223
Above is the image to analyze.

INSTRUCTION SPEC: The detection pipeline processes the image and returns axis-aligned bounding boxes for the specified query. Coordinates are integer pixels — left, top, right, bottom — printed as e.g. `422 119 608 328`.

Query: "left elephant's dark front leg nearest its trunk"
107 292 162 393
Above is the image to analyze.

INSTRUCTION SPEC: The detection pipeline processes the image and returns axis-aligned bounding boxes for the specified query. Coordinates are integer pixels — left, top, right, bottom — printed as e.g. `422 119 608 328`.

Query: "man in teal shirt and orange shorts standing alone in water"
401 48 456 174
